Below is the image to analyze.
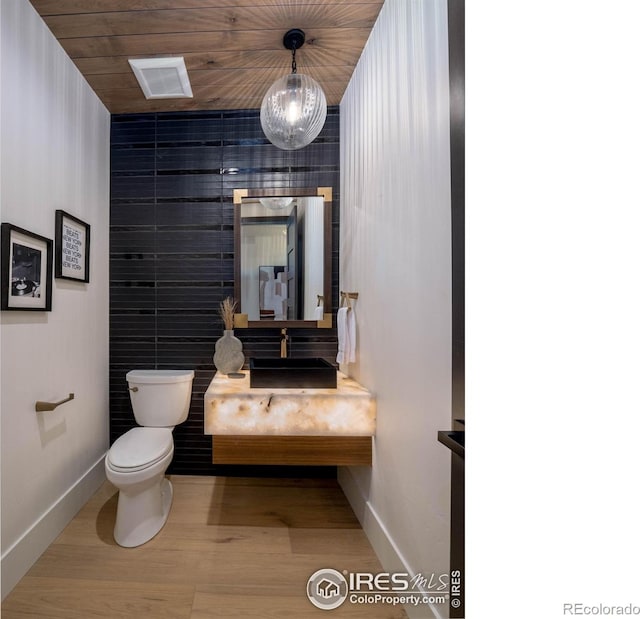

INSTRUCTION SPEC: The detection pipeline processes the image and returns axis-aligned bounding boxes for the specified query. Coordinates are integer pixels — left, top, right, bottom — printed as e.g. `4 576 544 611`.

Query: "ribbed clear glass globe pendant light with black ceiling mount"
260 28 327 150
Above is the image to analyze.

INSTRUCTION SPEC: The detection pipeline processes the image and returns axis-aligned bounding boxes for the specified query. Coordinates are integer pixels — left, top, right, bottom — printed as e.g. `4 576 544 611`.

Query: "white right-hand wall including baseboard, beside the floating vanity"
339 0 451 617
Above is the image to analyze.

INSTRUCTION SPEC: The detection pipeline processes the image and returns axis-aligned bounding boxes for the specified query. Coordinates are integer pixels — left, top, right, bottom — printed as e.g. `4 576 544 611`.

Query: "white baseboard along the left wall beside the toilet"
1 455 106 600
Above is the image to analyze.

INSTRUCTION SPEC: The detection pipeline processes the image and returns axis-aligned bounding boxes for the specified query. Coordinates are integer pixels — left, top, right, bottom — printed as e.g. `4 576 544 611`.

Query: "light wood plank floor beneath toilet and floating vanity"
2 475 407 619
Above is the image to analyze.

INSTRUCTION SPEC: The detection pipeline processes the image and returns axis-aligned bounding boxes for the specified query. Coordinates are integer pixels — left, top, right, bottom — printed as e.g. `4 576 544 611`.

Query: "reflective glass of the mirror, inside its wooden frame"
236 196 330 324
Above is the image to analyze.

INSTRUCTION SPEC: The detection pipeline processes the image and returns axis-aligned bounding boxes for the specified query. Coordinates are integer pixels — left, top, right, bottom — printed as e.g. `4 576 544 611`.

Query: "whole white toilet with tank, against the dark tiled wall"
104 370 193 548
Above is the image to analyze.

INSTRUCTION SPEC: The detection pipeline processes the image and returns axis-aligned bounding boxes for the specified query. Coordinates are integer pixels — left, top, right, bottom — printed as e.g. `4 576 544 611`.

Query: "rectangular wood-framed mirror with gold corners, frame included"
233 187 333 329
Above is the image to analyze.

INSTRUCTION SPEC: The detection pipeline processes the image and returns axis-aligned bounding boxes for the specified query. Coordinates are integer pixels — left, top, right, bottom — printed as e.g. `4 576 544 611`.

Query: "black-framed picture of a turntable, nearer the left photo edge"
0 223 53 312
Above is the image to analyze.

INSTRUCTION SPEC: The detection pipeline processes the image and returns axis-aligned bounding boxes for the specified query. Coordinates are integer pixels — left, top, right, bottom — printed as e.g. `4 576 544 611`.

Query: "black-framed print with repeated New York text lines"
56 210 91 282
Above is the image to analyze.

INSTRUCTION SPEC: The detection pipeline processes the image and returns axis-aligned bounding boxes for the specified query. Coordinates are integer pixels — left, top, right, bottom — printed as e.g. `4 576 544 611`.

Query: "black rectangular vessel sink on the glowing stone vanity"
249 357 337 389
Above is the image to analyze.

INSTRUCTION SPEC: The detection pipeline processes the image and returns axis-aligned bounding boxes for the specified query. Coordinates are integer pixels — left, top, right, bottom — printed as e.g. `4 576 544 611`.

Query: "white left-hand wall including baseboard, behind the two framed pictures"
0 0 110 596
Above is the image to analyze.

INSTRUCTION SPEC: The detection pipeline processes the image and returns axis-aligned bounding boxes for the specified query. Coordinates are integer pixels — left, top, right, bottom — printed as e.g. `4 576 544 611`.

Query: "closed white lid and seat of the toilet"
107 428 173 472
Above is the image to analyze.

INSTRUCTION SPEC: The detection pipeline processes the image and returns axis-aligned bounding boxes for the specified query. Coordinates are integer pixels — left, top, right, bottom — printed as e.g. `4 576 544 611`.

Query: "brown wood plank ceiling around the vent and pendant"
31 0 383 114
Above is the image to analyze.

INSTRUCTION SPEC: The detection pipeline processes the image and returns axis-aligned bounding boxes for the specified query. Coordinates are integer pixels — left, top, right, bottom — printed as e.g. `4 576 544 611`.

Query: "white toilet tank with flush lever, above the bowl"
127 370 193 428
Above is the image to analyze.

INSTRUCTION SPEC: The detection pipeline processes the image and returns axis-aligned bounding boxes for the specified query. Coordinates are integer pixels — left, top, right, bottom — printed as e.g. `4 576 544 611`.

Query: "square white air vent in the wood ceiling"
129 56 193 99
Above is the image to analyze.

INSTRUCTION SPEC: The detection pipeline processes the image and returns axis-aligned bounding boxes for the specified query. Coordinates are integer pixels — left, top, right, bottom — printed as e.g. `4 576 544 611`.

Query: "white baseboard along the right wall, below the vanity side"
338 467 448 619
